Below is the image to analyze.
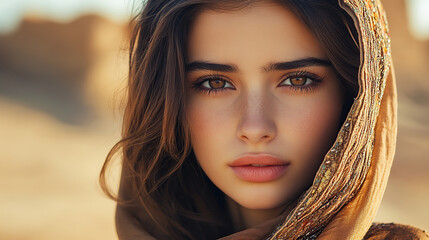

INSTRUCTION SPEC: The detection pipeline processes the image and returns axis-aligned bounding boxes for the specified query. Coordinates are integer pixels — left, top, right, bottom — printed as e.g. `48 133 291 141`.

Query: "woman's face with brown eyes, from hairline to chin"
186 3 344 210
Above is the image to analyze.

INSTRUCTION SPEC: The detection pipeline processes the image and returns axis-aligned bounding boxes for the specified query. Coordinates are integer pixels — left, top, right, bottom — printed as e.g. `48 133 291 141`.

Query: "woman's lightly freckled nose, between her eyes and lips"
237 94 277 145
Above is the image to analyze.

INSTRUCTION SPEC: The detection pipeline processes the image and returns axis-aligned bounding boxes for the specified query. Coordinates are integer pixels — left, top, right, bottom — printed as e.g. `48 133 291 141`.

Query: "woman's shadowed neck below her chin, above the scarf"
227 197 292 231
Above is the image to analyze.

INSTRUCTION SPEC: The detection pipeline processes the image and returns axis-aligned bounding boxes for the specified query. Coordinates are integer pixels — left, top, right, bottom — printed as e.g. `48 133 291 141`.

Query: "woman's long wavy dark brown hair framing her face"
100 0 360 239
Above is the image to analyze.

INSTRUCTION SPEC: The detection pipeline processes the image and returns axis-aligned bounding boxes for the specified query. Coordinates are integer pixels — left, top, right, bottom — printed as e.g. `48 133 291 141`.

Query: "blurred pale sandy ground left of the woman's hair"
0 99 119 240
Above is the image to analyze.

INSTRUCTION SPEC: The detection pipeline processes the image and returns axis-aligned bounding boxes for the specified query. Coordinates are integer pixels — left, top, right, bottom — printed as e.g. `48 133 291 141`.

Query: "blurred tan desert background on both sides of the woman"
0 0 429 240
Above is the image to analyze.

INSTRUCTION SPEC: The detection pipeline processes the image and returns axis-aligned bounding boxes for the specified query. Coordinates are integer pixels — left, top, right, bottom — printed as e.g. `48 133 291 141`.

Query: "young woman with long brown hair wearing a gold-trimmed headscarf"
101 0 427 239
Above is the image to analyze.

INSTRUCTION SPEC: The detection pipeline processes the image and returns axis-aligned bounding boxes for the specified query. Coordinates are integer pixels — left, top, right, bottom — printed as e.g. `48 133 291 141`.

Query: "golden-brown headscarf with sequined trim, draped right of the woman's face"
269 0 397 237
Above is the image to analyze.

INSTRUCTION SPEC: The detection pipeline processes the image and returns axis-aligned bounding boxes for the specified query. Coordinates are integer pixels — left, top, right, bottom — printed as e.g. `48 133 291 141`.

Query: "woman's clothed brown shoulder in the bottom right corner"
363 223 429 240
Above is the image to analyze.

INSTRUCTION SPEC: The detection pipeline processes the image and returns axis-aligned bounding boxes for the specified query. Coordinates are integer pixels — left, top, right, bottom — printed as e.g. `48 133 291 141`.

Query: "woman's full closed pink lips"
228 154 290 183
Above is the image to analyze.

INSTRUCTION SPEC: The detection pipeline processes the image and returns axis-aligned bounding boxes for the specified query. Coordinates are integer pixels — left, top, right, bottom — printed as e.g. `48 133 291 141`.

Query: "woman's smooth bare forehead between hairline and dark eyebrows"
187 2 325 64
